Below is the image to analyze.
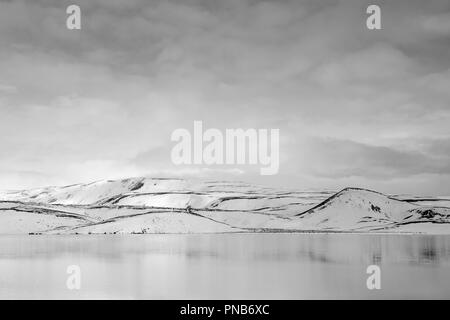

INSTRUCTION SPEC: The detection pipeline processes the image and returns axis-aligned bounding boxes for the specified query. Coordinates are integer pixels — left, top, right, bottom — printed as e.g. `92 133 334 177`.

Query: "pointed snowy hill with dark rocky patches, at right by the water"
280 188 450 232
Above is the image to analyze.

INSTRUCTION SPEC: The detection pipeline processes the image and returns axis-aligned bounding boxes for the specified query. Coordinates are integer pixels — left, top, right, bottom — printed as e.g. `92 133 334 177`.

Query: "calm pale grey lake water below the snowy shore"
0 234 450 299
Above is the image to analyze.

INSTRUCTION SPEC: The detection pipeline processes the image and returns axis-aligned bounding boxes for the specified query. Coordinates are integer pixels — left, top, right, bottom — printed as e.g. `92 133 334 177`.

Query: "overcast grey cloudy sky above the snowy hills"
0 0 450 195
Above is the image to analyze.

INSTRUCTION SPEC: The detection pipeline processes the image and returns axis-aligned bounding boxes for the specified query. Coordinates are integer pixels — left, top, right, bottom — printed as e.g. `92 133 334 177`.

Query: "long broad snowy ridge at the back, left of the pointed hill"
0 178 331 214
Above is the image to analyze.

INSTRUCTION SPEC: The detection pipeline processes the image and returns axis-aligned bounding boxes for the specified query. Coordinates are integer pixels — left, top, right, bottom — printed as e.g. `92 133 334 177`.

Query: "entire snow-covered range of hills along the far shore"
0 178 450 234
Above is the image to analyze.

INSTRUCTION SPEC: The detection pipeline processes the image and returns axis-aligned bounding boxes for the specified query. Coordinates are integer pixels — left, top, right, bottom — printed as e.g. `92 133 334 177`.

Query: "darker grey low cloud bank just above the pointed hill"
299 138 450 179
